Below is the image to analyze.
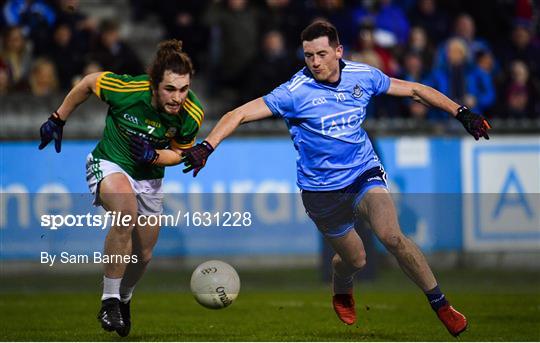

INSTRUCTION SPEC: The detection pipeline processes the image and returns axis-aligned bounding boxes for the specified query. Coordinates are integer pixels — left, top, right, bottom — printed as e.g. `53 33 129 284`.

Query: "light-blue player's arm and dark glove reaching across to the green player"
182 98 272 177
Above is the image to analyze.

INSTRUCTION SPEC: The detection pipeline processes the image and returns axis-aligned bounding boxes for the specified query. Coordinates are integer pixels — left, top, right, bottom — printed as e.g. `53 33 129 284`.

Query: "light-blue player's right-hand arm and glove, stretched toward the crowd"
387 78 491 140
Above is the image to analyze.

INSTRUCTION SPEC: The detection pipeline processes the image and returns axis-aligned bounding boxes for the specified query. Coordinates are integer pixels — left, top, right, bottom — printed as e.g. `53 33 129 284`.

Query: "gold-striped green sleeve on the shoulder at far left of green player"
96 71 150 107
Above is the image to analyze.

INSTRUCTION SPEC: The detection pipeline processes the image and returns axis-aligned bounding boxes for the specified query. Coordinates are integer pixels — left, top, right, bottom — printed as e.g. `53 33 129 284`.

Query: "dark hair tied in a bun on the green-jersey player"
148 39 194 89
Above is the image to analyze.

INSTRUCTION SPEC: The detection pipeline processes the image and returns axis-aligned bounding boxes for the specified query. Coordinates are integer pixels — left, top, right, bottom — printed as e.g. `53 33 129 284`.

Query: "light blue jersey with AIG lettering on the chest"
263 60 390 191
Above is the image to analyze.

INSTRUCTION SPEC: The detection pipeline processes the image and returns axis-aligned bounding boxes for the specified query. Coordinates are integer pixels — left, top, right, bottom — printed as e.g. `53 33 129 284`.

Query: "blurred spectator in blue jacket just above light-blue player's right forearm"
428 38 495 119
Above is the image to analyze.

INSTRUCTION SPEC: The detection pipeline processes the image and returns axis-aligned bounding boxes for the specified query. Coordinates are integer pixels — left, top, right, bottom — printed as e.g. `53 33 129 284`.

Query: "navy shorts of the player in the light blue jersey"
302 167 388 238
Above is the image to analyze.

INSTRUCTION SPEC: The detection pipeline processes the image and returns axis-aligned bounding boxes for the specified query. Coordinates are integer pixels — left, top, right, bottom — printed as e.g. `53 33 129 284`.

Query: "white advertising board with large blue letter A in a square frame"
462 136 540 251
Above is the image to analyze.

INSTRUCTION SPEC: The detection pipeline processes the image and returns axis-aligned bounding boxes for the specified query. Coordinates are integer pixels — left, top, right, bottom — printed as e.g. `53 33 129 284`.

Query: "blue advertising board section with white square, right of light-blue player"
377 137 462 252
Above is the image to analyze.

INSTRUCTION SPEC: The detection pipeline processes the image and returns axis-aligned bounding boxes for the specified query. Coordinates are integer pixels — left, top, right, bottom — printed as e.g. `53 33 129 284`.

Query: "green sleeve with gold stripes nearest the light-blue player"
174 90 204 149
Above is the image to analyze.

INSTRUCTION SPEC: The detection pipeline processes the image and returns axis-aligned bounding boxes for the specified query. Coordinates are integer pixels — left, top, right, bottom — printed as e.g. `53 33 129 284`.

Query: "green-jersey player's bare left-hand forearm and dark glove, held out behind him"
39 73 101 152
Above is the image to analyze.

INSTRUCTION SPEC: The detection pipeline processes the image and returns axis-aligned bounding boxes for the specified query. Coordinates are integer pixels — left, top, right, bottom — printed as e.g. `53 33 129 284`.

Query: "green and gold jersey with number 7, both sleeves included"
92 72 204 180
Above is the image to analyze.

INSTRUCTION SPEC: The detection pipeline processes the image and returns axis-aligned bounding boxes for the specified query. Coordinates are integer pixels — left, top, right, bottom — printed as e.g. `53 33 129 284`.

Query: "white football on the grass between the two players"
191 260 240 309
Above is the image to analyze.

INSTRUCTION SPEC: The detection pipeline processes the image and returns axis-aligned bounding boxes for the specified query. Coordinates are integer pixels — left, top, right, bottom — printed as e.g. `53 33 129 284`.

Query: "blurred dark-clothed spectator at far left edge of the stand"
0 26 32 90
